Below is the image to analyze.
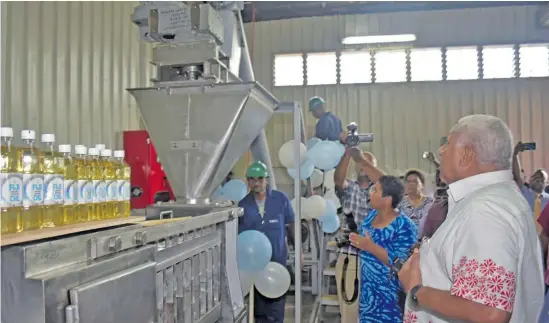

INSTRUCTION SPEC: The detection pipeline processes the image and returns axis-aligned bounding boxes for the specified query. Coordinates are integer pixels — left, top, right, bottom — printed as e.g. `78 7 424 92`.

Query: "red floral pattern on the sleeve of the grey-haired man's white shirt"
450 257 516 312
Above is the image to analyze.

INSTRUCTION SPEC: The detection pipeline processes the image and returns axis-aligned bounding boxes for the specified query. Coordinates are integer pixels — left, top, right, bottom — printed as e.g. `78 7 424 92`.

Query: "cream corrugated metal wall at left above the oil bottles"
1 1 152 148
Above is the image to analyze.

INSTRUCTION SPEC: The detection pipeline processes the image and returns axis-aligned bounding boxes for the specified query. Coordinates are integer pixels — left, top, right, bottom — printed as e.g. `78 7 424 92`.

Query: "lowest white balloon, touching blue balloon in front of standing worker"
255 262 291 298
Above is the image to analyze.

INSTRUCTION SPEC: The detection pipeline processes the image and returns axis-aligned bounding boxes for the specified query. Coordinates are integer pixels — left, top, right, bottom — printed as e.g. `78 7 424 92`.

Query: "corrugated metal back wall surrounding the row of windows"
246 6 549 180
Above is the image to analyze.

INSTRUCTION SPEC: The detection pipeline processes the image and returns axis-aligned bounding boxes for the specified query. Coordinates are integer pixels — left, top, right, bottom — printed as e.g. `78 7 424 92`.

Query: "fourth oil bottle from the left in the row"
59 145 78 224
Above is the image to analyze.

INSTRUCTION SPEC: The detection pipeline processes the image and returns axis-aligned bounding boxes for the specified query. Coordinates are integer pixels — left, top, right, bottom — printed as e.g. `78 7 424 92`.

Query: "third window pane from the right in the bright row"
446 47 478 80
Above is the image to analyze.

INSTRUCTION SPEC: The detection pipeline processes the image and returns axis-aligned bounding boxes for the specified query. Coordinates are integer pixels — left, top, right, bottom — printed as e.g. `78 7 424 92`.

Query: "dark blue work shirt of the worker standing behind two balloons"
238 190 295 266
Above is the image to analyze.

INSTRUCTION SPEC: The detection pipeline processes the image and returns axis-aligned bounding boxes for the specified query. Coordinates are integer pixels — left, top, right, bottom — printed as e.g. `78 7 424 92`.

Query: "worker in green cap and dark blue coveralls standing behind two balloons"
238 161 294 323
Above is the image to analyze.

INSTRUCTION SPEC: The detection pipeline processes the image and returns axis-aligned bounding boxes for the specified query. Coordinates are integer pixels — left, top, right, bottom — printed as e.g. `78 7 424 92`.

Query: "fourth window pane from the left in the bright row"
374 50 406 83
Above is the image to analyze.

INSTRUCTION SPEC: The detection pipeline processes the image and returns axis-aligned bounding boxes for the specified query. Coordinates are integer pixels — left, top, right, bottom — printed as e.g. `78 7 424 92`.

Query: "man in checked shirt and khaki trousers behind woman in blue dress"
334 146 383 323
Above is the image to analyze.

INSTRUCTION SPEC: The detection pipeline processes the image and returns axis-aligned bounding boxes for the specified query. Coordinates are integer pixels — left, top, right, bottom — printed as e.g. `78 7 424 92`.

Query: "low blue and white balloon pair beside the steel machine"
236 230 291 298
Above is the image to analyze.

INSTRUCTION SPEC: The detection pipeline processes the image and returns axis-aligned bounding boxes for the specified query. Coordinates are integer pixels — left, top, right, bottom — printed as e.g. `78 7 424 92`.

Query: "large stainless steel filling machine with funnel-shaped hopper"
1 1 310 323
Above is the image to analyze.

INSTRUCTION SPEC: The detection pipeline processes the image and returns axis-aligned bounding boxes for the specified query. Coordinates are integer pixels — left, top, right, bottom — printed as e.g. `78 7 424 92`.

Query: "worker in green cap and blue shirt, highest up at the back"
309 96 343 141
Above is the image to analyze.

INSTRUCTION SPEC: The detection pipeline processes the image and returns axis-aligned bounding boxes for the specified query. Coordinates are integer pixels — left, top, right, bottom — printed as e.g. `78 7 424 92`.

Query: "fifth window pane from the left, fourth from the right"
410 48 442 81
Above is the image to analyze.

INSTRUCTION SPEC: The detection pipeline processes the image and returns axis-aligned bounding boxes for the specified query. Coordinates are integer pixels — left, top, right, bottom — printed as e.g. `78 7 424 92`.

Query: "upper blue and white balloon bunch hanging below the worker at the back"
278 138 345 233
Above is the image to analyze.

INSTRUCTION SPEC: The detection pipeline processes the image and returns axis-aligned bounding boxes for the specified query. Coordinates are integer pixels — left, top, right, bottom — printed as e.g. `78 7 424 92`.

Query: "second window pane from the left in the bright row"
307 52 337 85
